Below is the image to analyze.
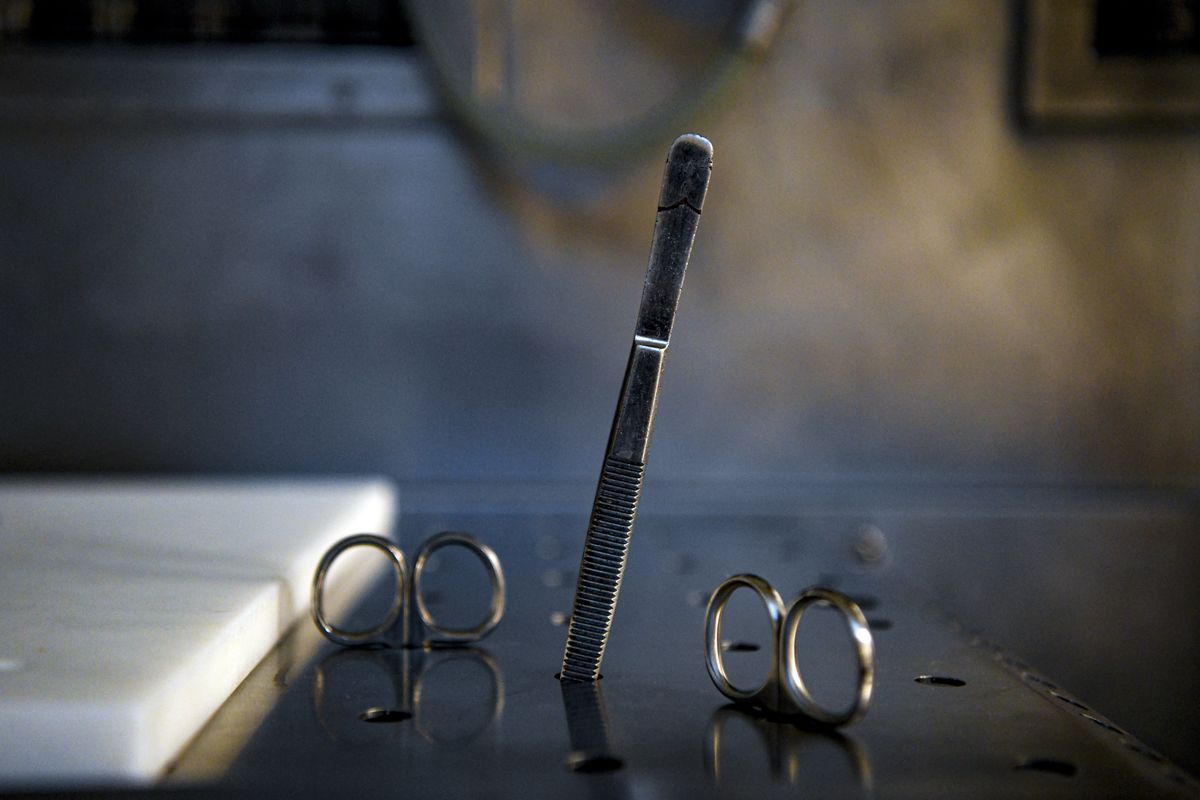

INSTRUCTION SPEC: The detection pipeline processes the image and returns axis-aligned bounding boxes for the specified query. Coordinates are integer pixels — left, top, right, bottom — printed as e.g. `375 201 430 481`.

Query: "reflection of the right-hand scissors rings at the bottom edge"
704 704 875 794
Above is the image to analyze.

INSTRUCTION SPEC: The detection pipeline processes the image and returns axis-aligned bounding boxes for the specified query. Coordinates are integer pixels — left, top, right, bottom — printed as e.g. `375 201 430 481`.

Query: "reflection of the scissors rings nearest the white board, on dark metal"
312 646 504 746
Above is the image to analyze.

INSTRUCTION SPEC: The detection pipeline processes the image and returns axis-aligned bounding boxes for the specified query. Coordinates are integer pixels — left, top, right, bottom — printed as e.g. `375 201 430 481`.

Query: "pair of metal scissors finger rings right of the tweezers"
704 575 875 726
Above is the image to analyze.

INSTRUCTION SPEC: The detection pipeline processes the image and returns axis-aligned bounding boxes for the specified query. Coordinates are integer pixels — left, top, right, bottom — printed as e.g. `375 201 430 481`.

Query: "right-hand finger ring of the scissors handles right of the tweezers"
780 587 875 726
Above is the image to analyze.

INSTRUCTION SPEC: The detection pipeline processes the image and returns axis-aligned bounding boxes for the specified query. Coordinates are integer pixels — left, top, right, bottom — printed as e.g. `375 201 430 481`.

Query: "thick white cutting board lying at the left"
0 480 395 788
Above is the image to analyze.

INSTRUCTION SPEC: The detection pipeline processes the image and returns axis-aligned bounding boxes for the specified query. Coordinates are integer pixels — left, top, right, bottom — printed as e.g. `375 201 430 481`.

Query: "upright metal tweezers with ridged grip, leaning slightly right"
559 133 713 681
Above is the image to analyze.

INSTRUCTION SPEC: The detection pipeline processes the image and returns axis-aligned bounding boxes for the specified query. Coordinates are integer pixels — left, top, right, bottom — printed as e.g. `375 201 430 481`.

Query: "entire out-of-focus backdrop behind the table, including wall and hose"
0 0 1200 771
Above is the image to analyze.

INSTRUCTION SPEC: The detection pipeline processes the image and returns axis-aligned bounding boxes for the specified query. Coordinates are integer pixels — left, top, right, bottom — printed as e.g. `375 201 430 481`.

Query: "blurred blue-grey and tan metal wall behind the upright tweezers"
0 0 1200 481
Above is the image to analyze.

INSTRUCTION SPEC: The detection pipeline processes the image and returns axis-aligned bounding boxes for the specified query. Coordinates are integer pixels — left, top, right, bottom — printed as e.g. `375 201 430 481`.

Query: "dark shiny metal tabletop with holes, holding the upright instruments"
9 503 1196 799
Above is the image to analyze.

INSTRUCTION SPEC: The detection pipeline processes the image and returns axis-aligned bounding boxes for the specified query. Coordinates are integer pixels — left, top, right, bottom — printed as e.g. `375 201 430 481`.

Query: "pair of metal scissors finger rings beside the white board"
312 531 504 646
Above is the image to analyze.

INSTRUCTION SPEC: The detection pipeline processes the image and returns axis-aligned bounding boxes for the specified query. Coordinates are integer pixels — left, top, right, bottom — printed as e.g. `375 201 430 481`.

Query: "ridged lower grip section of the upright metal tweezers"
562 458 646 681
